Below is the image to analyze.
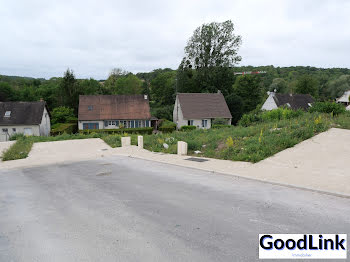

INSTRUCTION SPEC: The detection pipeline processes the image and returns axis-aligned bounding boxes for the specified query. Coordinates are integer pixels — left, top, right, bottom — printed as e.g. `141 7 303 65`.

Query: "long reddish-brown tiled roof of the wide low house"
78 95 151 120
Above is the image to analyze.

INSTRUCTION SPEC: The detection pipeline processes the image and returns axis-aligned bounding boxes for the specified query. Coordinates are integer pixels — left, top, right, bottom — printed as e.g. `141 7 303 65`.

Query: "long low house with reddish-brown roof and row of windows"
78 95 156 130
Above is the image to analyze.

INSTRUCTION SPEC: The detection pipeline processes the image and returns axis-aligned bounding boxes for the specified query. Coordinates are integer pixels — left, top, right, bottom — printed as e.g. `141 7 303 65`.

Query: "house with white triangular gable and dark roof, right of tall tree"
261 92 314 110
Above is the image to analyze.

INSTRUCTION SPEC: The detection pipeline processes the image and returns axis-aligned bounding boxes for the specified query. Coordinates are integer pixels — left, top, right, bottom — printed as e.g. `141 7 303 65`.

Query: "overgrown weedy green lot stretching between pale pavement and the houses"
3 110 350 163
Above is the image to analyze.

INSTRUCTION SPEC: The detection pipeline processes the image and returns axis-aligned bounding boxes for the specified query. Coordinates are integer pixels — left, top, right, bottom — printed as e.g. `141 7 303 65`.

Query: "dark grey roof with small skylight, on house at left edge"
0 101 46 126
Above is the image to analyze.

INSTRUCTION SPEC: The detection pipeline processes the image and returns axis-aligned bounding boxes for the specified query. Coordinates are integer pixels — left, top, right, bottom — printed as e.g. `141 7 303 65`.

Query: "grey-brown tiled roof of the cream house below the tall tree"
177 93 232 119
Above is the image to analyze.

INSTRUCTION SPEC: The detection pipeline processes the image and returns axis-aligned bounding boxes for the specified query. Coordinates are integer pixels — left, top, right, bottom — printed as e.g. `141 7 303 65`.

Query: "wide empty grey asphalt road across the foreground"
0 157 350 262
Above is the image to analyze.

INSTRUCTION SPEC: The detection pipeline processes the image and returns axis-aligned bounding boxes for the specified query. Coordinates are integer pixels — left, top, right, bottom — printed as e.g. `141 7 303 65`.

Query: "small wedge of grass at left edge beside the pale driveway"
2 138 33 161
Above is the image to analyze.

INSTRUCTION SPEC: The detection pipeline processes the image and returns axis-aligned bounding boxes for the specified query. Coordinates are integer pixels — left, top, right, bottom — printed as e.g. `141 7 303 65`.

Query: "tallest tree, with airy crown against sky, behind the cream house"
178 20 242 94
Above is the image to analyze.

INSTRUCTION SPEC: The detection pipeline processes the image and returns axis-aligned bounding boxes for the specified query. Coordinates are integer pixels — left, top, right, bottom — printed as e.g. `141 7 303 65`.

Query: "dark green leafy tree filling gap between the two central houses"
151 71 176 106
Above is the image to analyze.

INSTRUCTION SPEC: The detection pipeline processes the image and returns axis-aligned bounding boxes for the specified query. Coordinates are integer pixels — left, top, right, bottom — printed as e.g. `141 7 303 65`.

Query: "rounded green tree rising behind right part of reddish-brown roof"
112 74 143 95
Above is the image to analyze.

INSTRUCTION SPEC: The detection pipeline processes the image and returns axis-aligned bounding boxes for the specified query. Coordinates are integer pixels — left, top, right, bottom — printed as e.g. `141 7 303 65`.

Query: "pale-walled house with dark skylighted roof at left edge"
0 101 51 142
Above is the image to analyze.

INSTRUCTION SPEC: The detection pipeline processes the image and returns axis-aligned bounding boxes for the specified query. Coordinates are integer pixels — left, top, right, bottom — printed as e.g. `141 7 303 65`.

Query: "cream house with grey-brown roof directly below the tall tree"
173 92 232 129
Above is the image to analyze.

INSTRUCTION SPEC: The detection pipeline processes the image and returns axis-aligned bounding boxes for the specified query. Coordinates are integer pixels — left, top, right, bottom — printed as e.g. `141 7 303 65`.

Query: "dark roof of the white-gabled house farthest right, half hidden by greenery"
273 93 314 110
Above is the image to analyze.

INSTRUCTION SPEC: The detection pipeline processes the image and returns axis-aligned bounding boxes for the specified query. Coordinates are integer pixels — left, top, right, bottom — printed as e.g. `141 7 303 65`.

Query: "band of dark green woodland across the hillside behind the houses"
0 66 350 122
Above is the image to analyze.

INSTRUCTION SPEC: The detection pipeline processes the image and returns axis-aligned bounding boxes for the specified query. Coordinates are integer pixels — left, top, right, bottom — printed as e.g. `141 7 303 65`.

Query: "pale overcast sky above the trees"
0 0 350 79
